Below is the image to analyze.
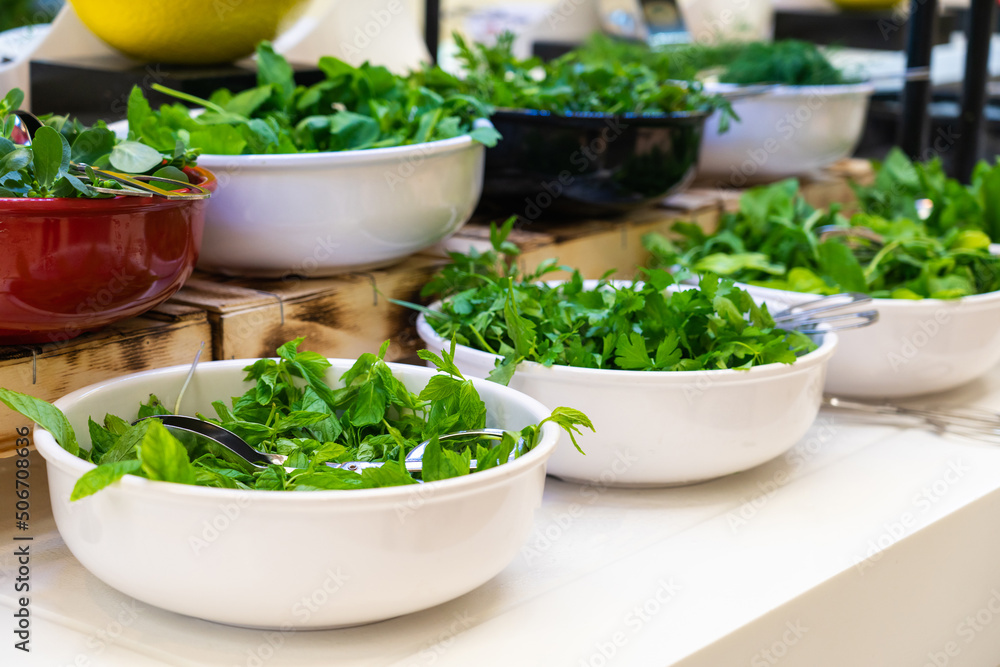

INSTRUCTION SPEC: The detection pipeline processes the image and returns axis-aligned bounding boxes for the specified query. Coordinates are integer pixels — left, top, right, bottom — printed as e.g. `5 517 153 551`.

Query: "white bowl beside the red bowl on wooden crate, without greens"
198 136 485 277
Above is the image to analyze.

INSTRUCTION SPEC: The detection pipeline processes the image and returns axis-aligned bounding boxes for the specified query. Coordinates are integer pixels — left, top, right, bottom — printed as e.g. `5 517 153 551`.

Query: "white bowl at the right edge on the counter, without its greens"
743 285 1000 398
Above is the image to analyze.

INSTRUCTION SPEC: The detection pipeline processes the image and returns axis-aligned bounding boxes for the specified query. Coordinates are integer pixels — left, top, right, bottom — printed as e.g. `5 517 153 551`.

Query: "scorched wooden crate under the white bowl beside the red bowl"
171 255 444 366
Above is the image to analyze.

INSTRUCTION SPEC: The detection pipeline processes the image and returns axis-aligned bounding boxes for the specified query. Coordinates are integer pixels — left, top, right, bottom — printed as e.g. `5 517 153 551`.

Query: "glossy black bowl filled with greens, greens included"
446 33 720 220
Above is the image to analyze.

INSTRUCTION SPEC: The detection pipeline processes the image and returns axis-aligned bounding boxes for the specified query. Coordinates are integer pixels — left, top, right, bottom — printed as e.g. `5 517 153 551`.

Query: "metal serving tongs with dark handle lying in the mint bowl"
132 415 524 473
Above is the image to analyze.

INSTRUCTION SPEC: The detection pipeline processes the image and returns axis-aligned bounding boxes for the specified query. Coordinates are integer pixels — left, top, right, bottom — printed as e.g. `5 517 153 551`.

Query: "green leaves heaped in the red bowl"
0 88 195 199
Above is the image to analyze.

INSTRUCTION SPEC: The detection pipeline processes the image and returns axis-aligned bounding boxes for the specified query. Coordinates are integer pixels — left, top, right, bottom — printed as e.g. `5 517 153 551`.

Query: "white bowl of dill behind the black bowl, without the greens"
698 83 874 188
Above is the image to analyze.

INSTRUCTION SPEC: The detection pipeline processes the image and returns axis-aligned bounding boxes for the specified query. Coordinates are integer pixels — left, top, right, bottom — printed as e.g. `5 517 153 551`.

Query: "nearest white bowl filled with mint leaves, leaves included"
7 339 585 631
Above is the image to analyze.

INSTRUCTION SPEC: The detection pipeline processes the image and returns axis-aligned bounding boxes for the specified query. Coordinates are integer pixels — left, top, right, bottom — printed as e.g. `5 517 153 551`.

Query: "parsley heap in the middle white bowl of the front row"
407 218 816 384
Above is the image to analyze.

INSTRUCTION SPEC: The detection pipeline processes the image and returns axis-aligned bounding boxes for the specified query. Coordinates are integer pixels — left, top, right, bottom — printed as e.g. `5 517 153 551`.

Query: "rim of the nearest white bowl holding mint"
33 358 559 507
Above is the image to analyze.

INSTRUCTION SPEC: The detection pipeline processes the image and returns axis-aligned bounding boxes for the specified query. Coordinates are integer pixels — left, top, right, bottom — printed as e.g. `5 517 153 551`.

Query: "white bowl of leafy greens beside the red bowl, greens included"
128 43 498 278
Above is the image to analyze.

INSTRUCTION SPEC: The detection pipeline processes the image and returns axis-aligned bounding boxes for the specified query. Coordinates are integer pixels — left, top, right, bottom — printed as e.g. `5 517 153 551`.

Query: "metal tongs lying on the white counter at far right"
823 395 1000 443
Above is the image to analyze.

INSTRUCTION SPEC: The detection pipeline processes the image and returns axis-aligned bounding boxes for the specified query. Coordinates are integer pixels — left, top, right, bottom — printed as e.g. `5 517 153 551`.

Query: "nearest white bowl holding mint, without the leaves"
35 360 558 629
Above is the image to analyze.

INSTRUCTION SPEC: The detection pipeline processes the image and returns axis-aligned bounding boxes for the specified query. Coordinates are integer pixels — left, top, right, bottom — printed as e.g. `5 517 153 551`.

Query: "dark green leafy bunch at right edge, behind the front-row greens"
854 148 1000 241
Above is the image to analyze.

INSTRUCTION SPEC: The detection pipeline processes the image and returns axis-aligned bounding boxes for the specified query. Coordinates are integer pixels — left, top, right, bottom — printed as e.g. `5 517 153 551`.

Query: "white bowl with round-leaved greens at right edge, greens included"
646 171 1000 398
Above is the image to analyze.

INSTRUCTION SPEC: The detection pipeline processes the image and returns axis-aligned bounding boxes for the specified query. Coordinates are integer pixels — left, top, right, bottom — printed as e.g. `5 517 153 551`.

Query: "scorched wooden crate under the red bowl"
0 302 212 452
